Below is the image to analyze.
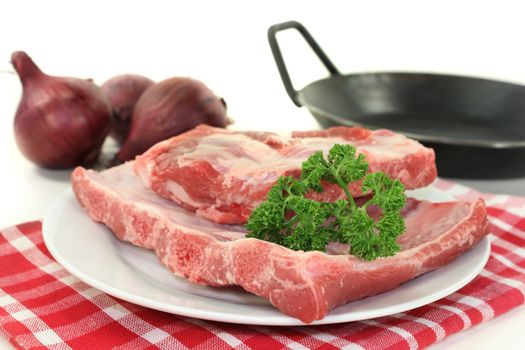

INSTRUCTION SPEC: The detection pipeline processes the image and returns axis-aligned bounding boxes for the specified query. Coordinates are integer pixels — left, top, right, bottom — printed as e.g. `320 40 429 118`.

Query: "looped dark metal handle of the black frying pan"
268 21 339 107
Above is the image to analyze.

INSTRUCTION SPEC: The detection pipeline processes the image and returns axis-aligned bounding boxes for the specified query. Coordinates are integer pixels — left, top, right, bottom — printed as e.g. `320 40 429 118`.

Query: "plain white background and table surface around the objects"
0 1 525 349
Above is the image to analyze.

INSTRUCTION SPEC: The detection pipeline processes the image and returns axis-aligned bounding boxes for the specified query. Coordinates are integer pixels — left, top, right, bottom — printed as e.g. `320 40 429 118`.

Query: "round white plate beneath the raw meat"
43 189 490 326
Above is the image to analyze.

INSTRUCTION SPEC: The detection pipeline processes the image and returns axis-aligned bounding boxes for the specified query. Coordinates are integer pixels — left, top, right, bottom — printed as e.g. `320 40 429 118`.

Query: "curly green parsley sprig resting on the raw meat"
246 144 406 260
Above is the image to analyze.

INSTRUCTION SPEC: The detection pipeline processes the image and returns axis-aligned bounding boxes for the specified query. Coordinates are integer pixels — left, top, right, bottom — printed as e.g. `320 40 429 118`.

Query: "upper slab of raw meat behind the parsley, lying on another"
135 125 436 224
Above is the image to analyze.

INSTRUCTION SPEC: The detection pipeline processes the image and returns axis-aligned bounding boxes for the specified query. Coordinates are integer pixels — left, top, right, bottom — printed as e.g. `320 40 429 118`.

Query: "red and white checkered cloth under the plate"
0 180 525 349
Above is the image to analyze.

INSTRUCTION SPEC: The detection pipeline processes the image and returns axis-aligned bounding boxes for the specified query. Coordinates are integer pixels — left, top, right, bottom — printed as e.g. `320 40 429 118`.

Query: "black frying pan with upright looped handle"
268 21 525 178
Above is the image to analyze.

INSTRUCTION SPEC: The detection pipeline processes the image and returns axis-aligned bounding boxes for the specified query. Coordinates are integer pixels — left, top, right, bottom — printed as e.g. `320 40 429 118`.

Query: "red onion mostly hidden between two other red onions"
101 74 153 143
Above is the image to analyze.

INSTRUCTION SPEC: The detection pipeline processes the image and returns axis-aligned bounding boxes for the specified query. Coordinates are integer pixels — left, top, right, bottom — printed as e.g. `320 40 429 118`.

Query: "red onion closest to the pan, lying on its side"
114 77 231 164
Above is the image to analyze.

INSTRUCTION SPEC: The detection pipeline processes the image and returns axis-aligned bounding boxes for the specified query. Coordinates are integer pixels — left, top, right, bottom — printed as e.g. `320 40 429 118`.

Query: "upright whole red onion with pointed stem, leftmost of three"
11 51 110 168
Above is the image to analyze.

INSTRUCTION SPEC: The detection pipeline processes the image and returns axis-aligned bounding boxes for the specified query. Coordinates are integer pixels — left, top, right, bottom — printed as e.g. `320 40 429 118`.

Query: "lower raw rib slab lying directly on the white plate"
72 162 487 323
